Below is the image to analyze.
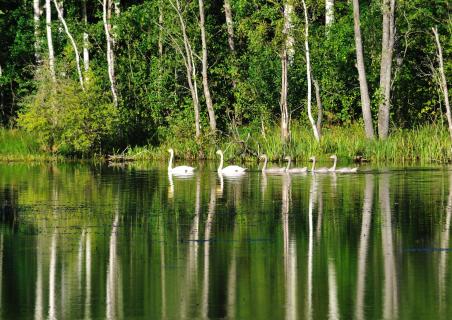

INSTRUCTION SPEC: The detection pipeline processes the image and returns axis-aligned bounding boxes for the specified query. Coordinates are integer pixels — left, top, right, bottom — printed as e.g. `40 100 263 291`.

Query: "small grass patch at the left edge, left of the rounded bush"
0 128 57 161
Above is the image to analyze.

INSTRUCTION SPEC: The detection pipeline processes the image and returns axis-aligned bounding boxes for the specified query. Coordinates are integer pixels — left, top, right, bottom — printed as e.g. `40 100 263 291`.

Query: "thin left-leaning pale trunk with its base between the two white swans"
169 0 201 138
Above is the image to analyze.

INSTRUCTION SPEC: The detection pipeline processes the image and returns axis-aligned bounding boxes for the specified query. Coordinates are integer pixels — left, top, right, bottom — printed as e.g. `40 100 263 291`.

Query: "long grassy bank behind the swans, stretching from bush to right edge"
127 124 452 163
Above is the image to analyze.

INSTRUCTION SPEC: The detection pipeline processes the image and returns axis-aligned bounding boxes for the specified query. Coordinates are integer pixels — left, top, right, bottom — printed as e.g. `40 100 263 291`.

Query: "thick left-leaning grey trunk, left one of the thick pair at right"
353 0 374 139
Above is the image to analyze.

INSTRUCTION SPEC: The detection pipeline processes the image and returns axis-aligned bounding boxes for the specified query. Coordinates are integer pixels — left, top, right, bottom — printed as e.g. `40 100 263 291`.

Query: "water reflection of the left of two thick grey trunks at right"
355 174 374 320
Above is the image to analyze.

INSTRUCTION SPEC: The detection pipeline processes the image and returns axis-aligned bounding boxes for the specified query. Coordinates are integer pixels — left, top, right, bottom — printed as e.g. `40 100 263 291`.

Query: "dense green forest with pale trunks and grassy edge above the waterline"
0 0 452 162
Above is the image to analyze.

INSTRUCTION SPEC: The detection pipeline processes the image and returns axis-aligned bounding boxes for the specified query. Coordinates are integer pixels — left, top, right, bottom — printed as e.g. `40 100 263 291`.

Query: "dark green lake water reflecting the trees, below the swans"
0 164 452 319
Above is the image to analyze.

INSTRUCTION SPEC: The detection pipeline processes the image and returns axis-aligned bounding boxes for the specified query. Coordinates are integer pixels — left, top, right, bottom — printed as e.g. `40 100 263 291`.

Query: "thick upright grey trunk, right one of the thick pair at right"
378 0 395 139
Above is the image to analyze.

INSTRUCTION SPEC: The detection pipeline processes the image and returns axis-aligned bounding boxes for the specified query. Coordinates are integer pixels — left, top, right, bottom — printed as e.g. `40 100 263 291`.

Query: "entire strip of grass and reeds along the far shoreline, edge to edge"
0 124 452 164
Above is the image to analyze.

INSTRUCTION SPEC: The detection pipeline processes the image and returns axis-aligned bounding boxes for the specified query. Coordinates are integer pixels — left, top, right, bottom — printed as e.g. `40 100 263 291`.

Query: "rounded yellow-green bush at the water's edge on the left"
18 69 118 154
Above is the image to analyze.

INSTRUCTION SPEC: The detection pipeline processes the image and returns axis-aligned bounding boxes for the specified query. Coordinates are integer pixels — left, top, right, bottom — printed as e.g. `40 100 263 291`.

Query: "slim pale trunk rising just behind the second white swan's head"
198 0 217 133
